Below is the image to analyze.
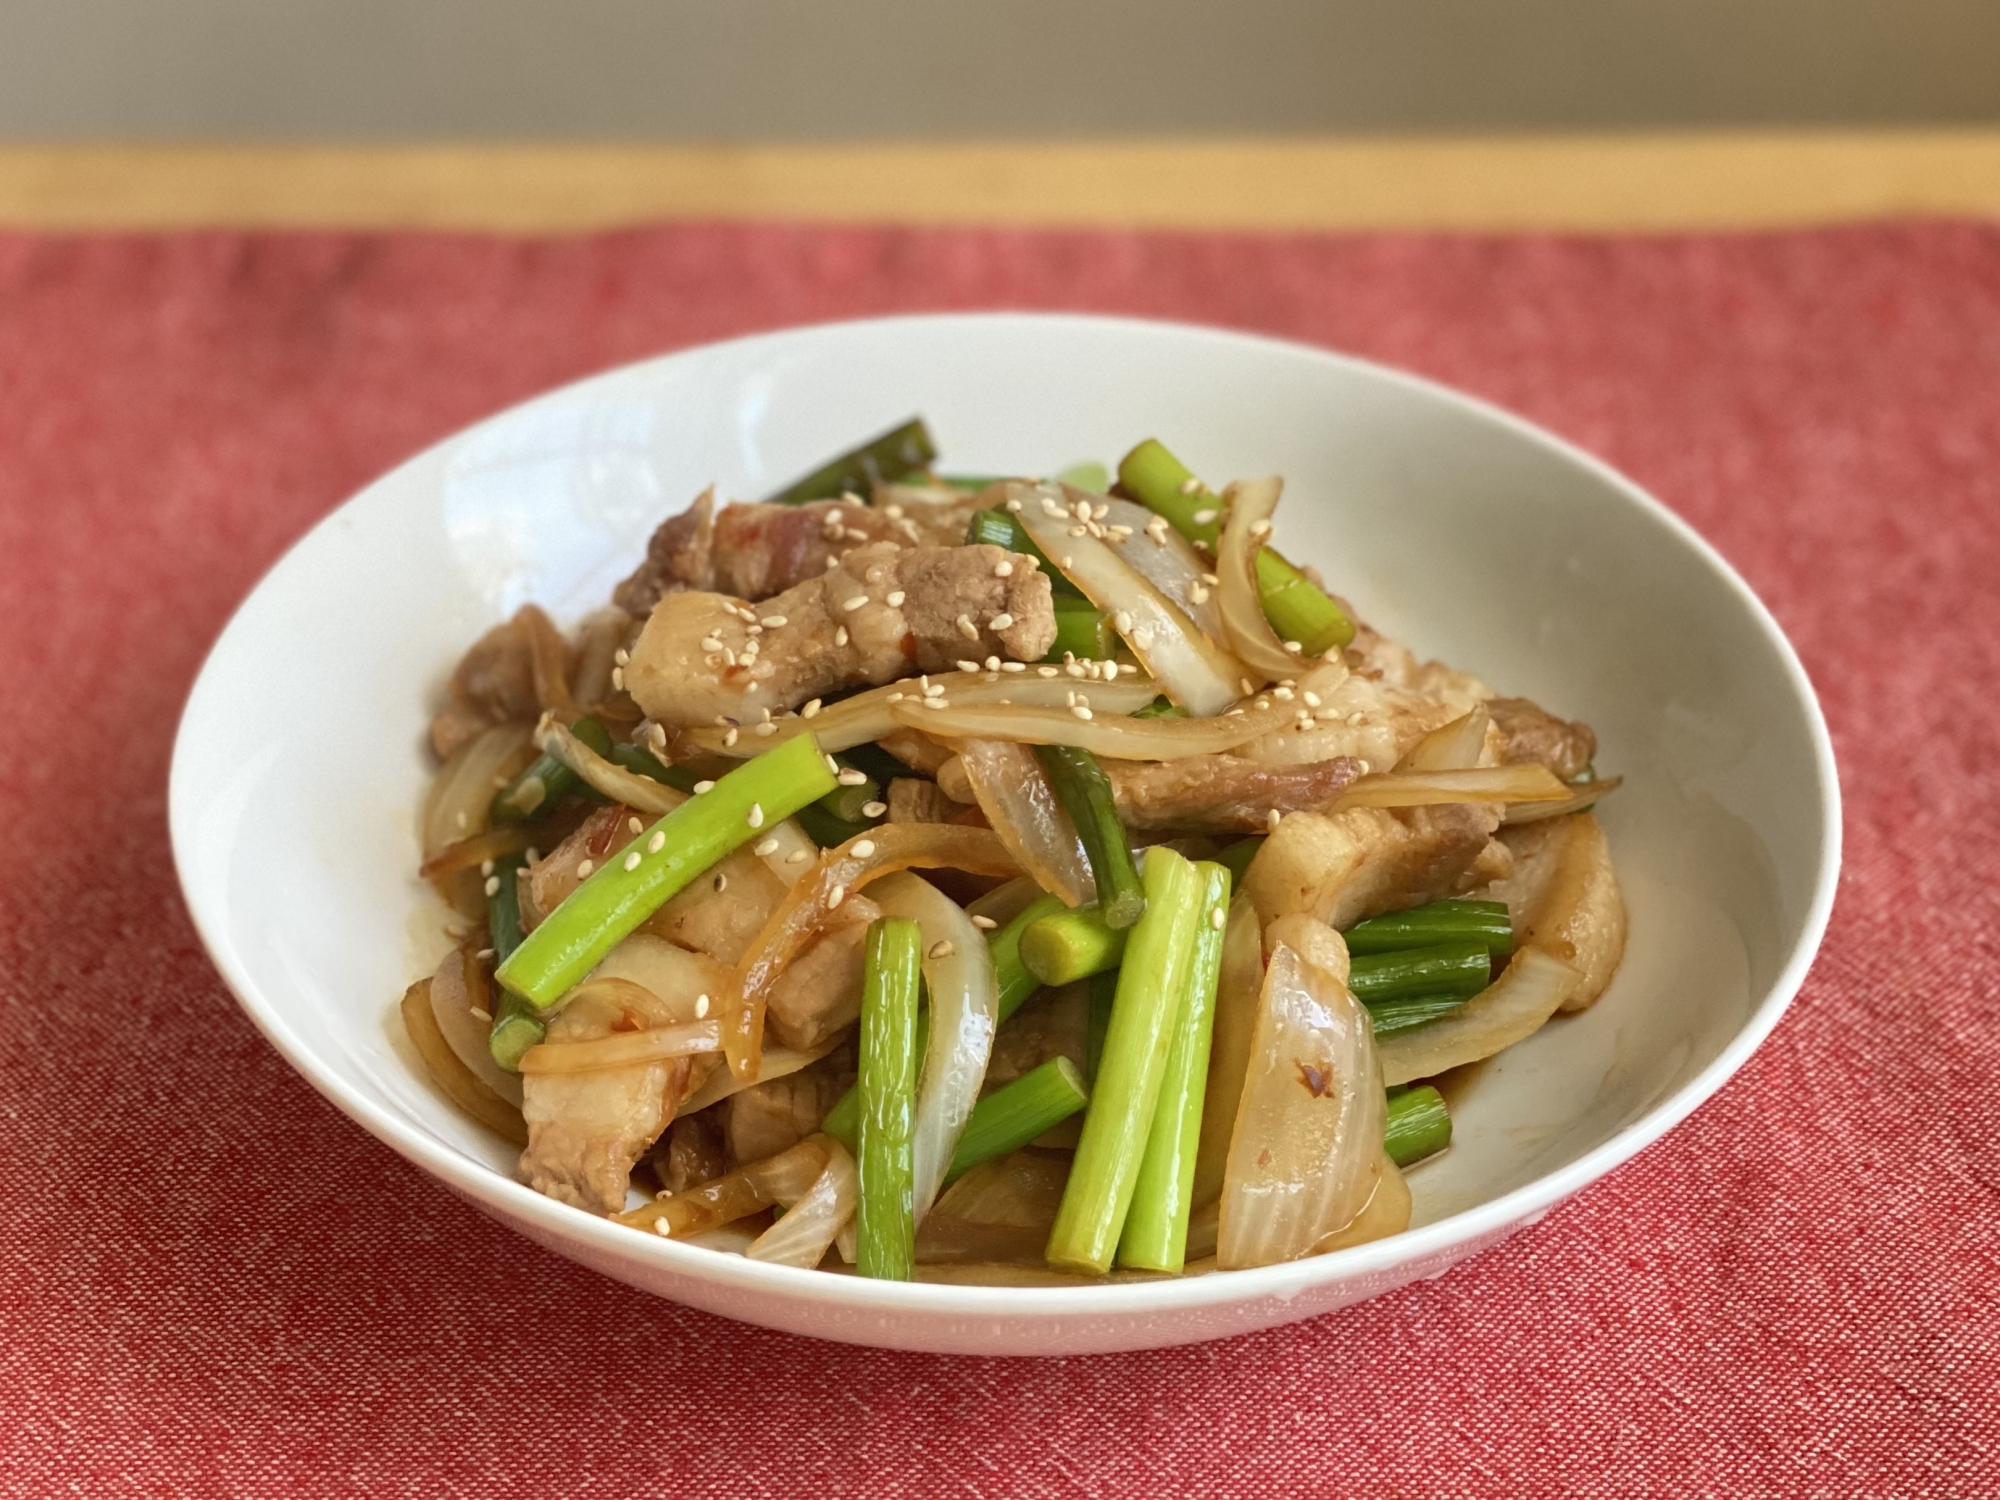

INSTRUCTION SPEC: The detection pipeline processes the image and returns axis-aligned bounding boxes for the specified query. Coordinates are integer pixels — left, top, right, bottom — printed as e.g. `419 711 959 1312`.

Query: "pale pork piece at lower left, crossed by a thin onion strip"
520 984 694 1214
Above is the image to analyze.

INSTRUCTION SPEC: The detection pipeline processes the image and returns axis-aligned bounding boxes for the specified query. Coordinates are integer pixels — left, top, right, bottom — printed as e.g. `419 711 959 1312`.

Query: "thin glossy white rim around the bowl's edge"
168 310 1842 1342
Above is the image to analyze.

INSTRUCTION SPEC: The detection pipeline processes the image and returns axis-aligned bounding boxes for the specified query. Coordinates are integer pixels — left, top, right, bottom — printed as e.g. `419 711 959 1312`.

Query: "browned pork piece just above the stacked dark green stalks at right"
1244 802 1508 928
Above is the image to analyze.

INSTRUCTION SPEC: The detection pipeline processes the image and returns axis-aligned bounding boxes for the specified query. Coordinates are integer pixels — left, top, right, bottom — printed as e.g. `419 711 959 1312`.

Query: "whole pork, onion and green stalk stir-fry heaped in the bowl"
402 422 1624 1284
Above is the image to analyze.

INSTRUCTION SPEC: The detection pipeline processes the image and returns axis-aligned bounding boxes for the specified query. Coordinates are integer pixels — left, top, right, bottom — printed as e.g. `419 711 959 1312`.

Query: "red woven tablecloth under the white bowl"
0 226 2000 1498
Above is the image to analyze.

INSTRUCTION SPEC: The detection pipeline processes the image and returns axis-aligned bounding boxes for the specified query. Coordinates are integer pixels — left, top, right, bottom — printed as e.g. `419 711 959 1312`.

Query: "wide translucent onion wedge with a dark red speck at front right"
1216 948 1388 1270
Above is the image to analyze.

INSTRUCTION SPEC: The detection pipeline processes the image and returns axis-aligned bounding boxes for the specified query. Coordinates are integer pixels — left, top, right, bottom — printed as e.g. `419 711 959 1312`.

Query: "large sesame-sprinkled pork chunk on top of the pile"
624 546 1056 728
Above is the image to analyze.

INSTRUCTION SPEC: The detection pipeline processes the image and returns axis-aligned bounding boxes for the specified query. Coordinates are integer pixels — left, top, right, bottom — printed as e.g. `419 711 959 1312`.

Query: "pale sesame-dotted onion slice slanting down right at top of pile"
1006 484 1248 718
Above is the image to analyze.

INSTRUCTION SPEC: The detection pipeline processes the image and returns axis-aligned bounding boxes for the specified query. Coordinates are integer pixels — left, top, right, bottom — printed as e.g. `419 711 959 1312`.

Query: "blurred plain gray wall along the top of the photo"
0 0 2000 140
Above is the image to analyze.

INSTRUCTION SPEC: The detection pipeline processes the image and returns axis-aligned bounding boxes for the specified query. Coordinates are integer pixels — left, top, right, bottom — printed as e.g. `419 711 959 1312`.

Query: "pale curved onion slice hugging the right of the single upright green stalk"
868 874 1000 1224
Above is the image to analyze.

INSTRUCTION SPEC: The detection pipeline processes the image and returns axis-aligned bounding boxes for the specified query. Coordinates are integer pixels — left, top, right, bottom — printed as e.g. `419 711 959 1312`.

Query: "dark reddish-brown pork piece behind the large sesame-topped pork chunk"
612 490 972 618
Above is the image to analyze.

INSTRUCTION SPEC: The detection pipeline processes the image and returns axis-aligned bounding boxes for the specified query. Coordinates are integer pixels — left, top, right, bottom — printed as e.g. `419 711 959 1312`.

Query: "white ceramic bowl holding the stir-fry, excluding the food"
172 314 1840 1354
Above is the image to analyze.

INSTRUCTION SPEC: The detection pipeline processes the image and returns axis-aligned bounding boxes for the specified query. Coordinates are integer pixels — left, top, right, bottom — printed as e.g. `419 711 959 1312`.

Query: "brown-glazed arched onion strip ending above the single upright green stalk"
718 822 1020 1080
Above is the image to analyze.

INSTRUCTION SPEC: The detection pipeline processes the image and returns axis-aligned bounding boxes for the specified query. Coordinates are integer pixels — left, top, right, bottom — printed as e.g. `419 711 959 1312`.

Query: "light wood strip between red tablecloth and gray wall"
0 130 2000 232
